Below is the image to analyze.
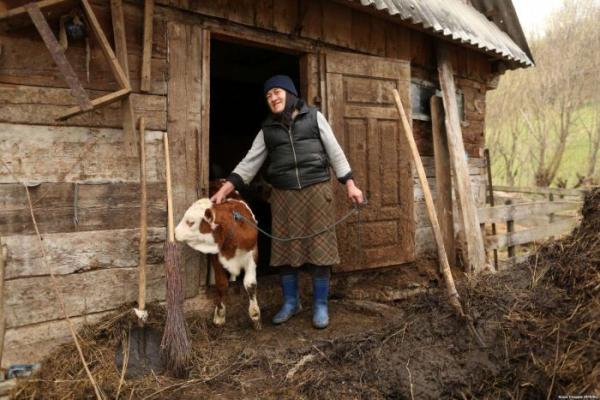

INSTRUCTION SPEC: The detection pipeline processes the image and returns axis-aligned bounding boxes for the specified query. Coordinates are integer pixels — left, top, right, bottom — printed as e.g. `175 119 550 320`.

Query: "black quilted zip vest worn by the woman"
262 105 330 189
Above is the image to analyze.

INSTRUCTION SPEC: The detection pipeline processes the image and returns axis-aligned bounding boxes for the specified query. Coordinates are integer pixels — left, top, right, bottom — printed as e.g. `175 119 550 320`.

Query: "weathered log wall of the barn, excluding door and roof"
0 0 490 366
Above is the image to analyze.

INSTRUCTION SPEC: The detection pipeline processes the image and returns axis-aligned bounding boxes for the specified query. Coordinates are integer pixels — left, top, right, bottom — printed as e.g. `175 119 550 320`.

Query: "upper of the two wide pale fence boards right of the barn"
477 201 581 223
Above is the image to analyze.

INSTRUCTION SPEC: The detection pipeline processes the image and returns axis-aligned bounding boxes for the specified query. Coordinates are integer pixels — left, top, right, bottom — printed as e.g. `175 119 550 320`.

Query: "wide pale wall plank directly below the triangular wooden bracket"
0 124 164 183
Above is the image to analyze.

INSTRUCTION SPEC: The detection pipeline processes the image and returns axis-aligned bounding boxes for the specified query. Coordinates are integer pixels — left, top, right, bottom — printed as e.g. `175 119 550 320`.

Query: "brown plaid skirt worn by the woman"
270 181 340 267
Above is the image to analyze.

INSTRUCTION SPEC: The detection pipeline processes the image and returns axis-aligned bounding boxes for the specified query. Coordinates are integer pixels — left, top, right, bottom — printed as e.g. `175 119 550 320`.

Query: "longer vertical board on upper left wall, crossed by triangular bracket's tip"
110 0 137 155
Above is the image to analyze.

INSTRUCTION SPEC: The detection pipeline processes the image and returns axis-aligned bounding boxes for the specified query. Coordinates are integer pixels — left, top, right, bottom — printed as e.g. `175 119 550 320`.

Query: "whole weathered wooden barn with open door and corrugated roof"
0 0 532 365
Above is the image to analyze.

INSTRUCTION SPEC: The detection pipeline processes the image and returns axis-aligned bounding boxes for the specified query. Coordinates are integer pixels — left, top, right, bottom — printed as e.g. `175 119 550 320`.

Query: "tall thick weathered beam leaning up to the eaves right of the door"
437 44 486 273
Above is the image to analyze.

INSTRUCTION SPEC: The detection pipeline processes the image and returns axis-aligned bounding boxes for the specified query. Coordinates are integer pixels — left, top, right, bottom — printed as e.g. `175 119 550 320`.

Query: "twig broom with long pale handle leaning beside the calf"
160 132 191 378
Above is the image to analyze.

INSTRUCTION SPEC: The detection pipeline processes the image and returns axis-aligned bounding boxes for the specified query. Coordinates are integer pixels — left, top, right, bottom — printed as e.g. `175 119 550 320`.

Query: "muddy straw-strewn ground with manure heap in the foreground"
10 190 600 399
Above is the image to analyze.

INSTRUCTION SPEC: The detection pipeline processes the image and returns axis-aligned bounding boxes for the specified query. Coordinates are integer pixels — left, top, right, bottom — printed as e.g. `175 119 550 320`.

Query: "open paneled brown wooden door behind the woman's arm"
325 52 415 271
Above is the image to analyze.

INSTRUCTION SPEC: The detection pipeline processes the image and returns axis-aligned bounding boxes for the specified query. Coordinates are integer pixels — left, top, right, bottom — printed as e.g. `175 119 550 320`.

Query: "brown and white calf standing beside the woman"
175 199 261 329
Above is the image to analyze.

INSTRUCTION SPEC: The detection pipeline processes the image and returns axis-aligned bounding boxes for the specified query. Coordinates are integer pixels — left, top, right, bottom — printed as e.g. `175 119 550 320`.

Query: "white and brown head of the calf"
175 199 219 254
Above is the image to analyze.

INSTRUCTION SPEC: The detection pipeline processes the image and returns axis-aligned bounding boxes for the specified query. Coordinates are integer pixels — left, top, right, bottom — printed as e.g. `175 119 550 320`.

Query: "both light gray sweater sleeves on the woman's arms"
232 112 351 184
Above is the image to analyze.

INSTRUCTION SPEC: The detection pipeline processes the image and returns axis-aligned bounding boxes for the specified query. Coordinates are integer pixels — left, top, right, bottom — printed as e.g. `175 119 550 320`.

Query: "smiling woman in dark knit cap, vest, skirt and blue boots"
211 75 363 329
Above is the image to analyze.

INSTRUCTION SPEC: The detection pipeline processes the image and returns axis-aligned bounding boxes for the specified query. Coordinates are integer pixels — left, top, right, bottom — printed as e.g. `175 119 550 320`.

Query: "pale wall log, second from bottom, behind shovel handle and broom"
6 264 198 328
